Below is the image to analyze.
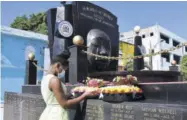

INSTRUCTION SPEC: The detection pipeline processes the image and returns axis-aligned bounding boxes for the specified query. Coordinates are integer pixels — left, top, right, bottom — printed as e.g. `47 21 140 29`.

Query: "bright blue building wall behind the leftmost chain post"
1 33 47 100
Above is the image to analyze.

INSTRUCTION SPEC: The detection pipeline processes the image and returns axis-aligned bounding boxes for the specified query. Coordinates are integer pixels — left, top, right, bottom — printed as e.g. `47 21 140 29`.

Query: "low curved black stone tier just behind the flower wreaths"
88 71 181 82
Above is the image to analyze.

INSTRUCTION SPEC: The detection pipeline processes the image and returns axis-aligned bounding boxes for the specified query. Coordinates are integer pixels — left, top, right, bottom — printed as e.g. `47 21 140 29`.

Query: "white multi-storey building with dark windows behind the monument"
120 25 187 70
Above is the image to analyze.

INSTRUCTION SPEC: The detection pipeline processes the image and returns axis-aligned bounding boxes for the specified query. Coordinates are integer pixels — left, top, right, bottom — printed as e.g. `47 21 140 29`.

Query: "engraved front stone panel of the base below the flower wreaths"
85 100 187 120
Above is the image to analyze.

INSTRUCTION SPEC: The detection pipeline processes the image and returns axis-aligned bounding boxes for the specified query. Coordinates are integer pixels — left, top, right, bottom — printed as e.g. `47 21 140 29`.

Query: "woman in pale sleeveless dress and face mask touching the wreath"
40 53 96 120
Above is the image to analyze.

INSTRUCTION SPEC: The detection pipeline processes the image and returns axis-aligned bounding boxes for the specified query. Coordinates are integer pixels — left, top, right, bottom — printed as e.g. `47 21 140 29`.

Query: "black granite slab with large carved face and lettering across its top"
72 2 119 73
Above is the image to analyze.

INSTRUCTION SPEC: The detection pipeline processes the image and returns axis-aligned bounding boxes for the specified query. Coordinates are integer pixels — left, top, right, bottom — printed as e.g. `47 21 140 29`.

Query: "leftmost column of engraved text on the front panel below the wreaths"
86 104 104 120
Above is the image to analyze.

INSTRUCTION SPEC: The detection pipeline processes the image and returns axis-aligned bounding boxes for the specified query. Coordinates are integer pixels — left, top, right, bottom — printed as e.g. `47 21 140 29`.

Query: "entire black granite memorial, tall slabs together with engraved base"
4 2 187 120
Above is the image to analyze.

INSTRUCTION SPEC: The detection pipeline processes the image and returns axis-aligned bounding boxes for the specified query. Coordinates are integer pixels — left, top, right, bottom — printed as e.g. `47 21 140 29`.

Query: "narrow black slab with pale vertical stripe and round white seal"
46 4 73 58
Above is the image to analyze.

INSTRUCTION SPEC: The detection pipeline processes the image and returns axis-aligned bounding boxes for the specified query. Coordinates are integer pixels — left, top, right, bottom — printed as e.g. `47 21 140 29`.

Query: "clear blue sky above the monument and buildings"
1 1 187 39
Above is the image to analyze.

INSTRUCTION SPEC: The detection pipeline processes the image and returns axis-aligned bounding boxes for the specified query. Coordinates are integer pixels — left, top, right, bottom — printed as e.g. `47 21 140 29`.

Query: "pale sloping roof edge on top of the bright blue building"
1 26 48 42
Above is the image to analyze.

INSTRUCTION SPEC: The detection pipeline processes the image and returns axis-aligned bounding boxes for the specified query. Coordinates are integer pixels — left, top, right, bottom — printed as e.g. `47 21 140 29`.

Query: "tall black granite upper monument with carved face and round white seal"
46 2 119 83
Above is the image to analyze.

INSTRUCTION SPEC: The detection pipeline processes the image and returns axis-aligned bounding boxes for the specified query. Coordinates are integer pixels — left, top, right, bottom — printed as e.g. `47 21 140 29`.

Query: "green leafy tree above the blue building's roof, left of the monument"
10 13 47 34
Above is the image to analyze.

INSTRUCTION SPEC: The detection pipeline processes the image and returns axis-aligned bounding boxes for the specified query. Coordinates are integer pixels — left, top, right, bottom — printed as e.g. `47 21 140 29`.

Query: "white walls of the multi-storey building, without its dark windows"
120 25 187 70
